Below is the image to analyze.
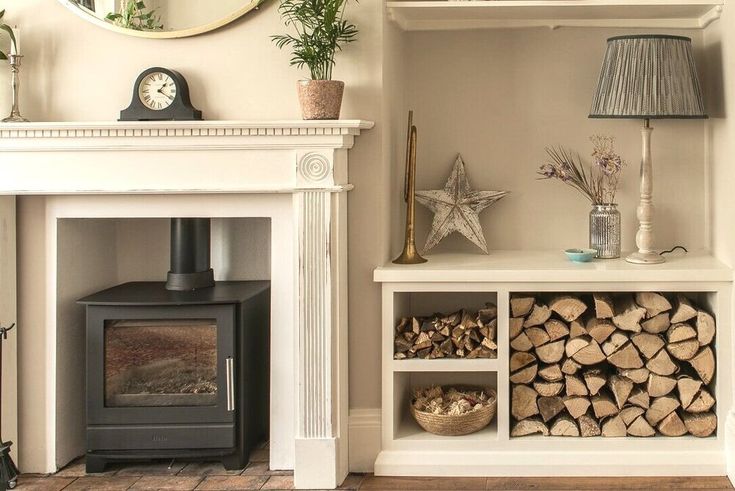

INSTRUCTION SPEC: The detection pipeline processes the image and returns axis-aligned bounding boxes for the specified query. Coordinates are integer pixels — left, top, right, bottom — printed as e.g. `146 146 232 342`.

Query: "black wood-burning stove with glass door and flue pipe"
79 219 270 472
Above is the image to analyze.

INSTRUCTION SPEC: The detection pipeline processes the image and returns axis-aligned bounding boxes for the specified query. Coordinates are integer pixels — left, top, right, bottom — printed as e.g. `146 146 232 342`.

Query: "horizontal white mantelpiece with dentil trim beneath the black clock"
0 120 373 194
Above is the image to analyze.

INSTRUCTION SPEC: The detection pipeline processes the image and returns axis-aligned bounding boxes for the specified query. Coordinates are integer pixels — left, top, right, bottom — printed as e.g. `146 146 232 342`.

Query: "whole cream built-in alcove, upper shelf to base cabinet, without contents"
374 0 733 476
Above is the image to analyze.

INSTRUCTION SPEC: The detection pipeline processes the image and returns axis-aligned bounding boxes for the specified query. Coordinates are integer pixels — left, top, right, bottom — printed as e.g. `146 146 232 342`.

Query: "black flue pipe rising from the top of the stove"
166 218 214 291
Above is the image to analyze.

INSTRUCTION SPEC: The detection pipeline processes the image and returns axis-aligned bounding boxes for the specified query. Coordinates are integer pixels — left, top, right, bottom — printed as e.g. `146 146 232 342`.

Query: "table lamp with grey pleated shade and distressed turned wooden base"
589 34 707 264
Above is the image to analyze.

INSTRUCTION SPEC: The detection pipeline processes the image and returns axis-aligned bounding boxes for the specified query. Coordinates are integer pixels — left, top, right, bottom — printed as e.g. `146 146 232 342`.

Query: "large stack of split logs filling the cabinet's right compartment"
510 292 717 437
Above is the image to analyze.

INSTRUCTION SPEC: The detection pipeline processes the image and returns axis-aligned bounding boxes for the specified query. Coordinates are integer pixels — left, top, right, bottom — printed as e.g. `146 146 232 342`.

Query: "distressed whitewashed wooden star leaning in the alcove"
416 155 508 254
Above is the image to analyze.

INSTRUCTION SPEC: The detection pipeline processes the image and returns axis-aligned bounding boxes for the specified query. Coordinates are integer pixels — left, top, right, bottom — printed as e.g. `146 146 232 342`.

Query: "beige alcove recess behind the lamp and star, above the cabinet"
384 0 722 255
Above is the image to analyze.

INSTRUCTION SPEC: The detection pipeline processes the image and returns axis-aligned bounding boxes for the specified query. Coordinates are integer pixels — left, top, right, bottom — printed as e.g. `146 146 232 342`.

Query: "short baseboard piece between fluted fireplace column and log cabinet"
349 408 381 472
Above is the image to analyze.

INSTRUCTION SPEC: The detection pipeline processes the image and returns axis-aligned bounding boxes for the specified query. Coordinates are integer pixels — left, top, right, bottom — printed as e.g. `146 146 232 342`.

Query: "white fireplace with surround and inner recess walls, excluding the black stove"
0 120 373 489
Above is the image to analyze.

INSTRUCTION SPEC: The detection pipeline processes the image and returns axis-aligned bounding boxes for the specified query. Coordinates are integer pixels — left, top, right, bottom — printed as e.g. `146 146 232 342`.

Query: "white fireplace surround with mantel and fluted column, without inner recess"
0 120 373 489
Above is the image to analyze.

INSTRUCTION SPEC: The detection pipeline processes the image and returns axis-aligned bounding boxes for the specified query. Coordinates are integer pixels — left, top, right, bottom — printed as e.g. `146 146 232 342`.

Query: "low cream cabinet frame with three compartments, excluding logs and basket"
374 251 733 476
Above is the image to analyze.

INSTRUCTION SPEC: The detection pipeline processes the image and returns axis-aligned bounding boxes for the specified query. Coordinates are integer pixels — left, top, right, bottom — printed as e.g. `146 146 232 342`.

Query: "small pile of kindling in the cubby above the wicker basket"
393 303 498 360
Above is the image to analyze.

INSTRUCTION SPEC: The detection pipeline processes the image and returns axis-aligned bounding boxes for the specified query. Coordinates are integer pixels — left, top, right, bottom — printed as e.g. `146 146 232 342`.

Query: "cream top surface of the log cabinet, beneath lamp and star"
374 251 733 283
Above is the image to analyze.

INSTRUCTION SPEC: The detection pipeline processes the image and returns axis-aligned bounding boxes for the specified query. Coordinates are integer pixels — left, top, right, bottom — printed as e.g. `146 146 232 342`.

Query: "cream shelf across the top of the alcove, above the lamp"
387 0 725 31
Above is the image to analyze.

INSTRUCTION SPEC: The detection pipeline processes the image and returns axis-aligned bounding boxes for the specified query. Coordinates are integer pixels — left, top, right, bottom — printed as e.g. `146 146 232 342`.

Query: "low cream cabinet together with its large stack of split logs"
374 251 735 476
